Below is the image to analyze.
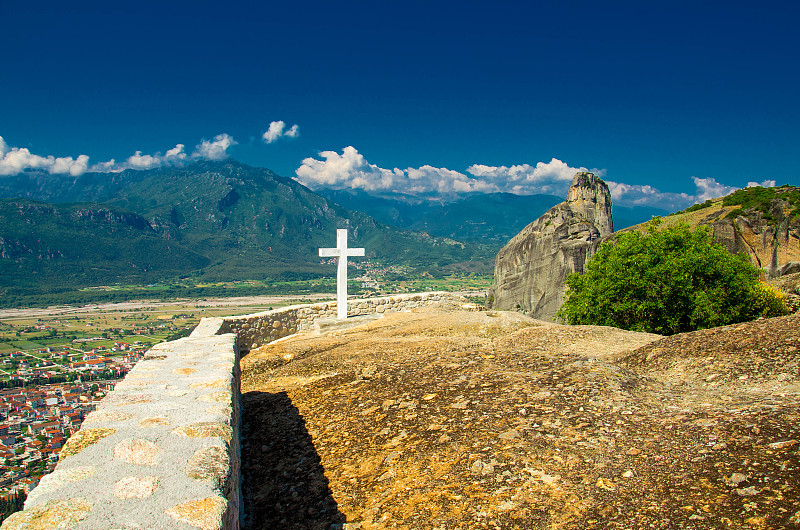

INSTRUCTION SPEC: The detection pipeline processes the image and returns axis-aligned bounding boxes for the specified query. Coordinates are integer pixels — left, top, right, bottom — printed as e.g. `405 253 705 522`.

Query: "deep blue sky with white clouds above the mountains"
0 0 800 208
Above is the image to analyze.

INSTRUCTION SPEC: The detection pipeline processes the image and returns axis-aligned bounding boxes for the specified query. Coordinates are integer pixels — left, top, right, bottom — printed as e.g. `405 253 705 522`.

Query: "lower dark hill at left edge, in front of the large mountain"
0 199 210 290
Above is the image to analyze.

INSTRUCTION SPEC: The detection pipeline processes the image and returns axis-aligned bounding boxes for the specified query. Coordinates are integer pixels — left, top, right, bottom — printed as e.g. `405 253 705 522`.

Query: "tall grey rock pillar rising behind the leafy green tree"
488 172 614 320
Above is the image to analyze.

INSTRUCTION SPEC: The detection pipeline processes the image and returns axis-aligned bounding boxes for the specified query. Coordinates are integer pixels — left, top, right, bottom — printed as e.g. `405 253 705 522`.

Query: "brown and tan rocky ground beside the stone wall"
242 309 800 530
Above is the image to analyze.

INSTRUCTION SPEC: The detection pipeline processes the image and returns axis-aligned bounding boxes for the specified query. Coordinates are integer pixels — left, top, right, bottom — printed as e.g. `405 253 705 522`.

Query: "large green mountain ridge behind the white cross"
0 160 492 287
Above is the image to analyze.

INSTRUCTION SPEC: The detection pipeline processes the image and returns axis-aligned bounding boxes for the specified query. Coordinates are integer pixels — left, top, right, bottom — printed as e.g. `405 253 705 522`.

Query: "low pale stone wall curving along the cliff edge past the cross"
2 293 464 530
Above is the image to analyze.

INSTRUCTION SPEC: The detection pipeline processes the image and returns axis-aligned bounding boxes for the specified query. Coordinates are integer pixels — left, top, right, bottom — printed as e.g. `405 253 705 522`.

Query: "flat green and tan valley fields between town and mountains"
0 270 491 381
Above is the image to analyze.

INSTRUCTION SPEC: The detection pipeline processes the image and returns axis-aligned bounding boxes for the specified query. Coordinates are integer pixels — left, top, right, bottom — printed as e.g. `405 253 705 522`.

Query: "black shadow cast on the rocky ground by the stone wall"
242 392 345 530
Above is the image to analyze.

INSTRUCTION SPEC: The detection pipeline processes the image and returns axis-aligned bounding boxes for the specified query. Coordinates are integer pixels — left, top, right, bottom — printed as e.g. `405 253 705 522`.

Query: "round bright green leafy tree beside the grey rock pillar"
559 218 788 335
